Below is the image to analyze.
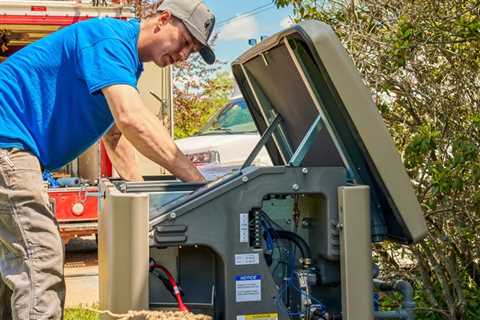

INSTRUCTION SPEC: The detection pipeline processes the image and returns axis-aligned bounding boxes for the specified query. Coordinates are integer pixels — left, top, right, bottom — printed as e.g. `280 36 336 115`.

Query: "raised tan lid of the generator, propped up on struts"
232 21 426 243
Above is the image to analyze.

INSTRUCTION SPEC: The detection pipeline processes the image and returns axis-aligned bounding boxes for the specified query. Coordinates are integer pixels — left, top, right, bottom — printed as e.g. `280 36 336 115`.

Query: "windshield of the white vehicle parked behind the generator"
198 99 257 135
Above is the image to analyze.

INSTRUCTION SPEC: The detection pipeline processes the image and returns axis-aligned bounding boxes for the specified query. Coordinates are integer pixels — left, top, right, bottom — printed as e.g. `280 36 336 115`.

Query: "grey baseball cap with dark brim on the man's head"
157 0 215 64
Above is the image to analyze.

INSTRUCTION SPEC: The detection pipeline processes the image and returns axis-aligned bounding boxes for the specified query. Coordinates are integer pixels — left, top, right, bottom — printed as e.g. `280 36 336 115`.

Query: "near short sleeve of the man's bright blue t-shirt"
77 39 138 94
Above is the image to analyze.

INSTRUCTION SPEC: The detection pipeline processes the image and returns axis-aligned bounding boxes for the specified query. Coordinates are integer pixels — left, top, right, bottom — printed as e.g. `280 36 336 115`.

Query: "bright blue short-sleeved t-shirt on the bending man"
0 18 143 169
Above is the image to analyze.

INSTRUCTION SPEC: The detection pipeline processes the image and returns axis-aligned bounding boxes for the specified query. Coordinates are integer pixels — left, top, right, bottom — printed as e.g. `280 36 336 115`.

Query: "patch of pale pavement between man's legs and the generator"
65 238 98 308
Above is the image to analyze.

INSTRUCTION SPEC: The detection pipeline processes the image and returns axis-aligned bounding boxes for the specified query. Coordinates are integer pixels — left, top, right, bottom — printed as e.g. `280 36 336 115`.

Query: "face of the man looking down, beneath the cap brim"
151 17 200 67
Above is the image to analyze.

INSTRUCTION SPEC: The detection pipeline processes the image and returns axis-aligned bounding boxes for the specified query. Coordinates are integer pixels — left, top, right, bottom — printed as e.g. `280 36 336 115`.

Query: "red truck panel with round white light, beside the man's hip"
48 187 98 222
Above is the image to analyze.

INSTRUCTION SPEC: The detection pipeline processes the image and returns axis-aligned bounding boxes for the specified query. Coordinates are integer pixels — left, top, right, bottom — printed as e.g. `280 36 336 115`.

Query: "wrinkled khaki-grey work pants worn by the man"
0 149 65 320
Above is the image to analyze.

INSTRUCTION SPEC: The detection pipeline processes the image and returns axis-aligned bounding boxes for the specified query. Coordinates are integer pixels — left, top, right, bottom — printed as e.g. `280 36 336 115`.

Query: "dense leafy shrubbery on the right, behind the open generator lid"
276 0 480 319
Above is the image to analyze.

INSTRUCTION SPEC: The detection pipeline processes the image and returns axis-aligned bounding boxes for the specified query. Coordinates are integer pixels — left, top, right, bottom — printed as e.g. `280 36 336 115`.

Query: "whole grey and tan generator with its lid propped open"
99 21 426 320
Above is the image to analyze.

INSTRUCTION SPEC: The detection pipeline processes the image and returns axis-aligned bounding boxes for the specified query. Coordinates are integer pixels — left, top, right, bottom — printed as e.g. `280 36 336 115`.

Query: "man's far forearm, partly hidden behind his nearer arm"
103 125 143 181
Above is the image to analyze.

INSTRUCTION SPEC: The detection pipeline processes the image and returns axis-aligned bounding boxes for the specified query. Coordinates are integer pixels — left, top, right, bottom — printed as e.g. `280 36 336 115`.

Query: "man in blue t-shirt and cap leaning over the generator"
0 0 215 320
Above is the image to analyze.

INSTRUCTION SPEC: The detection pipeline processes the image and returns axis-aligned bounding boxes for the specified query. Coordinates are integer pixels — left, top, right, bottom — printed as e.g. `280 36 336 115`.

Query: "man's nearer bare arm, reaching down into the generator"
102 85 205 182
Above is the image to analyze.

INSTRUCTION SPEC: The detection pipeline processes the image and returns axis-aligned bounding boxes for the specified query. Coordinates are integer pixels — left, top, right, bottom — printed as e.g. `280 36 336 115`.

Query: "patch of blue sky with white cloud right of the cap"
204 0 292 65
